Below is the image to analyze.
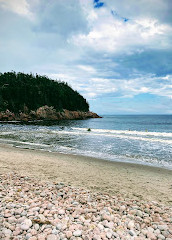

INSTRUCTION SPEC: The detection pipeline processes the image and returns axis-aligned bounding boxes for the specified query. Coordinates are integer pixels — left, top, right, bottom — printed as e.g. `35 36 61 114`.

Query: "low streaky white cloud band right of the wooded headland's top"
45 61 172 100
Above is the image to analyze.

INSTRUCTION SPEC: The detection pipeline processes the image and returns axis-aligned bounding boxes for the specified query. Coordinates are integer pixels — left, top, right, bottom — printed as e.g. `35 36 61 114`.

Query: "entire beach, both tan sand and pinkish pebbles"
0 145 172 240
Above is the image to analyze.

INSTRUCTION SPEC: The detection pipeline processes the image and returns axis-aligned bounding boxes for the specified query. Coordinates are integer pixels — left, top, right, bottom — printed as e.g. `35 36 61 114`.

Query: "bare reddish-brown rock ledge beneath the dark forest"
0 106 101 122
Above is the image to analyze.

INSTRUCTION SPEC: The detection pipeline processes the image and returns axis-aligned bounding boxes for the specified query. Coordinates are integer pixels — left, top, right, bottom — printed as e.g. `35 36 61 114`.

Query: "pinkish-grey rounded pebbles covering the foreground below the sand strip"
0 173 172 240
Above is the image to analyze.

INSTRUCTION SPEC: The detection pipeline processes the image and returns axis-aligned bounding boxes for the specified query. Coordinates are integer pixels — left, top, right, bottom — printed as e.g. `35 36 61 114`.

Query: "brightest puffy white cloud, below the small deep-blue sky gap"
71 3 172 54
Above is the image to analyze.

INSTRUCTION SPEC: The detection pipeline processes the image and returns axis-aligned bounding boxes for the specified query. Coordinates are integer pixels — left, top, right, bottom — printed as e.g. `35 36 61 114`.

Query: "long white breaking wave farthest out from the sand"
0 127 172 144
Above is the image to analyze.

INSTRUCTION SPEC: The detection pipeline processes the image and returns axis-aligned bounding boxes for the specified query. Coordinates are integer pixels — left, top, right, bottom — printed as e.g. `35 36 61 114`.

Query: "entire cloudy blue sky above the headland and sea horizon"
0 0 172 114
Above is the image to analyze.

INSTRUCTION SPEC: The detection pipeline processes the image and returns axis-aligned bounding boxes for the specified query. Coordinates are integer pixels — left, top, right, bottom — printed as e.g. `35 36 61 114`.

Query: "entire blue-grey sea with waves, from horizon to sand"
0 115 172 169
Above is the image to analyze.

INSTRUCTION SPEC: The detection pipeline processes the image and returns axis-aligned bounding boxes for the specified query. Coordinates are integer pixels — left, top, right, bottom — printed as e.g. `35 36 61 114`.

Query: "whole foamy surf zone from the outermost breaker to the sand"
0 127 172 169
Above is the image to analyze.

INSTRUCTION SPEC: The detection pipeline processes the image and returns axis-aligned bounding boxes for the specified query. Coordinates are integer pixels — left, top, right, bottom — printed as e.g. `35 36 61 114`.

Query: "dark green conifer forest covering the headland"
0 71 89 113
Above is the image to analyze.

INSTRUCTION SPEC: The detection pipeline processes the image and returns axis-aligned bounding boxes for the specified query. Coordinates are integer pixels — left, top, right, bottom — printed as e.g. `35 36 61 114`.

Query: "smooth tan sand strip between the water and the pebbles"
0 144 172 205
